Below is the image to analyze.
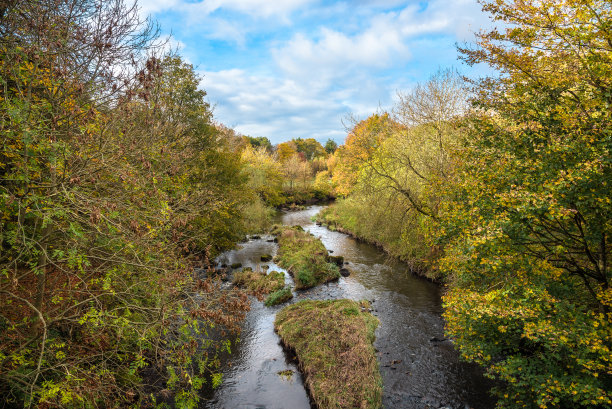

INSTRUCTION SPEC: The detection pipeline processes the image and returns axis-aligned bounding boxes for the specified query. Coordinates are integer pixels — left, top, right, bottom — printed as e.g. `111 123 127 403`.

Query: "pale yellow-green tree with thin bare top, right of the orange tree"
364 70 466 219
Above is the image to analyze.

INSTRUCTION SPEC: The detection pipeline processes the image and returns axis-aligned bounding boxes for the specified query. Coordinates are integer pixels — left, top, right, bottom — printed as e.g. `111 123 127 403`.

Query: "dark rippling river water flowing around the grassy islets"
201 206 494 409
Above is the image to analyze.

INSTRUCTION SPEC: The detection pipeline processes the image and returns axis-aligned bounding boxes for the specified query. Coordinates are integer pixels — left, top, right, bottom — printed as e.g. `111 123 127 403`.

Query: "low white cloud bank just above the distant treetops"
201 69 380 143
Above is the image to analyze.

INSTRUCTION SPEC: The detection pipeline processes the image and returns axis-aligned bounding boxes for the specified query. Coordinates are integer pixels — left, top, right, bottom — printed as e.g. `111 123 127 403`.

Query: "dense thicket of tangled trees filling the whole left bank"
0 0 246 407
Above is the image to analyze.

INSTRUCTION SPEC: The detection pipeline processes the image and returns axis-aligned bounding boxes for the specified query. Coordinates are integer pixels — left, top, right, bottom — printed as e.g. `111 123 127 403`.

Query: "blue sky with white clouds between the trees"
138 0 491 144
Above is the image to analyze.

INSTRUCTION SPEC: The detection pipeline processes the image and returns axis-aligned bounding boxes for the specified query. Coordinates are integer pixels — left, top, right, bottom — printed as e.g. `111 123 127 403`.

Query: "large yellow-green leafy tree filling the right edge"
442 0 612 408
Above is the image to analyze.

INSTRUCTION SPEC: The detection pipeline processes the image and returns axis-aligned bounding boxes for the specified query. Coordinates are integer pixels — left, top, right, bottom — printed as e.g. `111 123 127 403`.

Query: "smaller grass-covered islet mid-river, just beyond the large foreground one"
276 227 340 290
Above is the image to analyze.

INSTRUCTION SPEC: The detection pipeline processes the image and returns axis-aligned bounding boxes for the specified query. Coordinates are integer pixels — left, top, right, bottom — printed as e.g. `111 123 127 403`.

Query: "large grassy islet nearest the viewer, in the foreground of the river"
274 300 382 409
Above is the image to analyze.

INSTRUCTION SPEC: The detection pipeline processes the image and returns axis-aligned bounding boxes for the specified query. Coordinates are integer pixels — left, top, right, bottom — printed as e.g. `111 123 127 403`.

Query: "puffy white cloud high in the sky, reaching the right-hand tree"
272 0 483 87
